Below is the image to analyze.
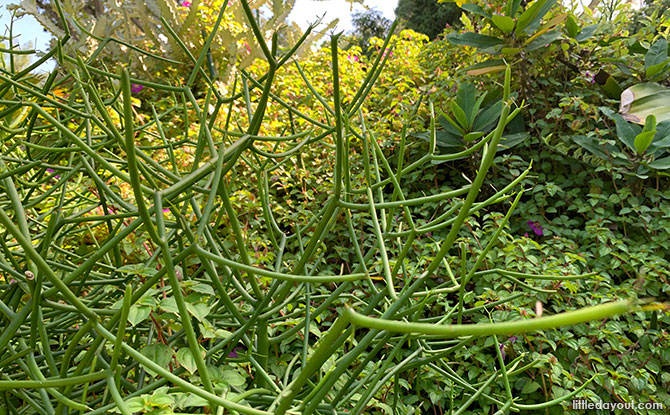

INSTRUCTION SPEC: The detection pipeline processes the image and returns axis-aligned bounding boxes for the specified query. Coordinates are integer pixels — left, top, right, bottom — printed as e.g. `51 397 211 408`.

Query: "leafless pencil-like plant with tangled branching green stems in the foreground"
0 0 633 415
